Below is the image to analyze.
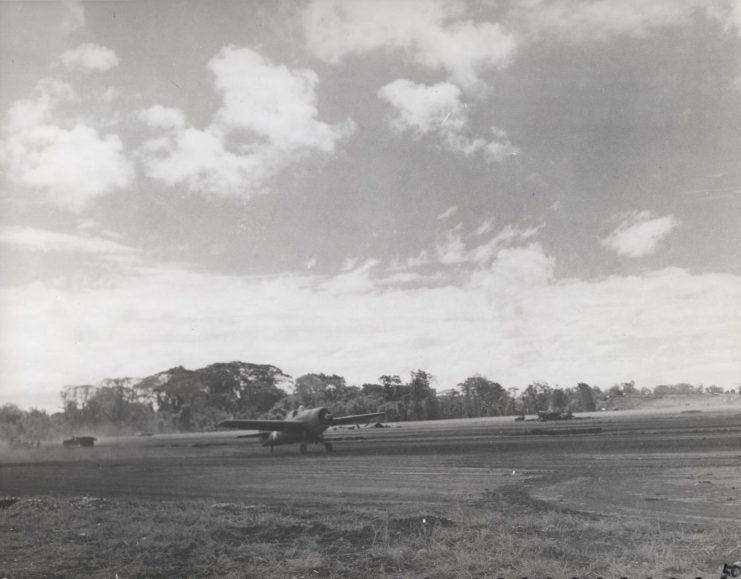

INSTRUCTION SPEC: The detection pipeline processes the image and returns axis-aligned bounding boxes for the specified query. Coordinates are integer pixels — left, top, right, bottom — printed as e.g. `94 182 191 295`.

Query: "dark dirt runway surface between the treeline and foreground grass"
0 410 741 525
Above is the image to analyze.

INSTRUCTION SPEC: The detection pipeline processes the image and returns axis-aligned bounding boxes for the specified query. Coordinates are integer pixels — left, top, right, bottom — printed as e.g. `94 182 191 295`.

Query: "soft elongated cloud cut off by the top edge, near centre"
304 0 516 87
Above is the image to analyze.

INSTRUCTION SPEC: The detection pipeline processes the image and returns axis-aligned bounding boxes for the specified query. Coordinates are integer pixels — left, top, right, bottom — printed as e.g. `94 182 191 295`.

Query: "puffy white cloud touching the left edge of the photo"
0 80 133 212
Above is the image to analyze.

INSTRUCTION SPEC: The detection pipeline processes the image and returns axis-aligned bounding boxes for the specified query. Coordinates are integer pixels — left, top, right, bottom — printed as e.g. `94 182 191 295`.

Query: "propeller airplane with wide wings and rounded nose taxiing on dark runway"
217 406 386 454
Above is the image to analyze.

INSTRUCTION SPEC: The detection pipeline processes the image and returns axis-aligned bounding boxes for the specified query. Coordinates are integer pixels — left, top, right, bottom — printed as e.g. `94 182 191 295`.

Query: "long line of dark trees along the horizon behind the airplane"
0 362 741 447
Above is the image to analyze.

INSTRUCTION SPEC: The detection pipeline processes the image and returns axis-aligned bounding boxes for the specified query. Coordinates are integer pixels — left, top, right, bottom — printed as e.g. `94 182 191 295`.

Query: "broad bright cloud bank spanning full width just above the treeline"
0 251 741 404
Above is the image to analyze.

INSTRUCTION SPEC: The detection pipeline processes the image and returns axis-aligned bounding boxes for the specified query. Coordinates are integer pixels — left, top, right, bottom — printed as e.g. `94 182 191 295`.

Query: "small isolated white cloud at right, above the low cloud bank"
602 211 680 257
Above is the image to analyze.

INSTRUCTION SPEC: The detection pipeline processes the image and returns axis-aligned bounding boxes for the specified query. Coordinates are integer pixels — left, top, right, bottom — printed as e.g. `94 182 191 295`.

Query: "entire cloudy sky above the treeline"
0 0 741 410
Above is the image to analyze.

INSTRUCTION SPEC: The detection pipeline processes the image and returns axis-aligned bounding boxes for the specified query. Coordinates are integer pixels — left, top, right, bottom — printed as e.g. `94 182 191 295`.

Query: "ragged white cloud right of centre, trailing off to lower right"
378 79 518 162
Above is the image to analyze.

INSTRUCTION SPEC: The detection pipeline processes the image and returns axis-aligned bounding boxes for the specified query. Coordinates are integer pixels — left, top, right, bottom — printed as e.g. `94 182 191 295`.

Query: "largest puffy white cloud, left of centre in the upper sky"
139 46 355 197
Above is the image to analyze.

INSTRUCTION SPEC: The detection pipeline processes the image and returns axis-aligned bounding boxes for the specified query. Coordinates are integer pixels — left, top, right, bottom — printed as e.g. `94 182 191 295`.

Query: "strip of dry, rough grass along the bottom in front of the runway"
0 487 739 579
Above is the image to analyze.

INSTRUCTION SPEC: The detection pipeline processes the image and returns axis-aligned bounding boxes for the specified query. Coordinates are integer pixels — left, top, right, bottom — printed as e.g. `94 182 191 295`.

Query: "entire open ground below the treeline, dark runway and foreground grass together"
0 412 741 579
